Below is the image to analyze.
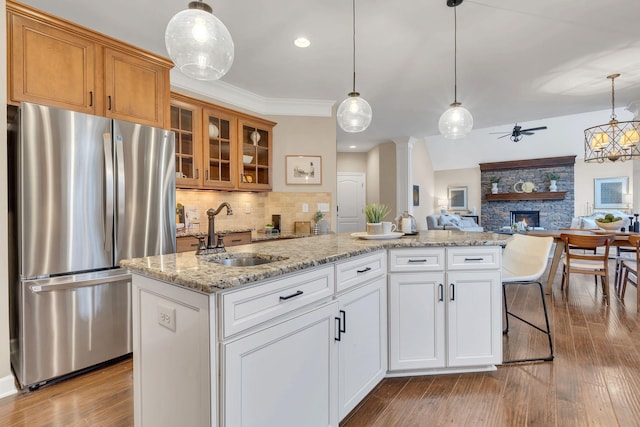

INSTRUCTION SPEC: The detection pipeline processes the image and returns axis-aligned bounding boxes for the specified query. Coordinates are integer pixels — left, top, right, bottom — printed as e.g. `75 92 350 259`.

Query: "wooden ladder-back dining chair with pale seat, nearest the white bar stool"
560 233 615 304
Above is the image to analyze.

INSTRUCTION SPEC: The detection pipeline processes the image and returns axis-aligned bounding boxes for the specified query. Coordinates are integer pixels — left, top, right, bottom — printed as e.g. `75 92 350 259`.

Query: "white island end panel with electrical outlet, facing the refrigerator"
132 274 217 427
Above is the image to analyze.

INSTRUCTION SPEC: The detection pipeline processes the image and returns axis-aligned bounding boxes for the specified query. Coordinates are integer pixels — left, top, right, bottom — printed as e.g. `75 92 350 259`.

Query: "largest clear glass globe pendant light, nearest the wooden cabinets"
164 0 234 80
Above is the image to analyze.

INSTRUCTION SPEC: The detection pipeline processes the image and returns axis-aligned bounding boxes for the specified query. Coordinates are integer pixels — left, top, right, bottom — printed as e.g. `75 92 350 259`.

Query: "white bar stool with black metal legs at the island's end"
502 234 553 364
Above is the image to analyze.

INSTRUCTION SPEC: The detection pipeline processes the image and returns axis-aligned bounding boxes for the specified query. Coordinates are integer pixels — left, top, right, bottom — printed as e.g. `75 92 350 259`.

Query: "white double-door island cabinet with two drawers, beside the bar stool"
389 247 502 375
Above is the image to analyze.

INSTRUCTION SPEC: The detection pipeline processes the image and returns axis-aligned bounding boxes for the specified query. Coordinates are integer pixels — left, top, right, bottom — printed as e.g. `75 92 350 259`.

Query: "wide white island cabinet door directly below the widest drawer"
220 301 338 427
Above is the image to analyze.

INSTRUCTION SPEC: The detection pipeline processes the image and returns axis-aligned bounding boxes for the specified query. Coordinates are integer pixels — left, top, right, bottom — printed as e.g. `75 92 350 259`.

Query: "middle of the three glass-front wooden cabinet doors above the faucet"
203 108 237 188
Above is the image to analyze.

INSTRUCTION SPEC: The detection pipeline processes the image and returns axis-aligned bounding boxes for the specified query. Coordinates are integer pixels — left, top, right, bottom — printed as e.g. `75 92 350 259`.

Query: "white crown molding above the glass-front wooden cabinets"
171 68 336 117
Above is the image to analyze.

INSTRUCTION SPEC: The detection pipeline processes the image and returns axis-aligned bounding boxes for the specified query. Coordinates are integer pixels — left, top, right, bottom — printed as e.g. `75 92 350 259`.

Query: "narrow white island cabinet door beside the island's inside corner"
338 275 387 420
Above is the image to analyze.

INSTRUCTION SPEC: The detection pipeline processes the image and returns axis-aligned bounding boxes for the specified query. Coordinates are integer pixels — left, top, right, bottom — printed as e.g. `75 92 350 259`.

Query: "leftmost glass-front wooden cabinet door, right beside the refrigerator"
171 100 202 187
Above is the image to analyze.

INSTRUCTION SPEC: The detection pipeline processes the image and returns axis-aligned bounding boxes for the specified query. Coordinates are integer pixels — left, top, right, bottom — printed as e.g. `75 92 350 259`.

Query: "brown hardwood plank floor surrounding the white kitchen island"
0 262 640 427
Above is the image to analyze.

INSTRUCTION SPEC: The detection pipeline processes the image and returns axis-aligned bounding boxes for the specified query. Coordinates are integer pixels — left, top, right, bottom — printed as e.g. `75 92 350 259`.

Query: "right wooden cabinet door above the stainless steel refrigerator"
104 48 169 127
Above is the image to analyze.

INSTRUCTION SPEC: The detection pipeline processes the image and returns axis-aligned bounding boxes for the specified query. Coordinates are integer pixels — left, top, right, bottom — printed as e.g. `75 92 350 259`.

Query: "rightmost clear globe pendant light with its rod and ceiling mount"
438 0 473 139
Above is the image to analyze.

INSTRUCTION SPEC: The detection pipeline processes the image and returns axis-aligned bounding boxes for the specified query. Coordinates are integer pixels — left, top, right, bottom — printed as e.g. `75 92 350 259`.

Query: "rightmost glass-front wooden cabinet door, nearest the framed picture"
238 119 274 190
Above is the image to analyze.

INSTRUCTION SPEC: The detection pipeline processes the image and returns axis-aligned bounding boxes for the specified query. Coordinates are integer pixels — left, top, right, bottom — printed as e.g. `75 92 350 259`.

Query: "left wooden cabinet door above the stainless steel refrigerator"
8 14 96 114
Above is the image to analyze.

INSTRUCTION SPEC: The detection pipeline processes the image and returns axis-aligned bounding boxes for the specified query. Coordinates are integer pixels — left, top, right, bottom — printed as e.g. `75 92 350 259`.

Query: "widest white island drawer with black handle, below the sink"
220 266 334 338
